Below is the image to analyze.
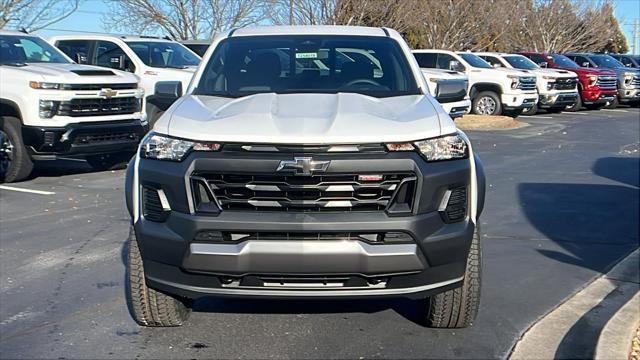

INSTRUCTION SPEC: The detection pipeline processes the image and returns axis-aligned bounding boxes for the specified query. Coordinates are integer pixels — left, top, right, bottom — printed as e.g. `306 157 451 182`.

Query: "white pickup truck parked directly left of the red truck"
475 52 580 115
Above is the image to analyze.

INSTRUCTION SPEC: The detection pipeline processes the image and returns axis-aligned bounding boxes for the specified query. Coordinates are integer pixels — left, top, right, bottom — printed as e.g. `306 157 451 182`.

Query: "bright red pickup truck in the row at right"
520 52 618 111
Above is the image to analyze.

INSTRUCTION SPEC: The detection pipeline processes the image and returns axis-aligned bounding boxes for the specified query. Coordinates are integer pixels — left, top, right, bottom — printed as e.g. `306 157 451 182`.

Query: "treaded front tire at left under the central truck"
126 227 190 326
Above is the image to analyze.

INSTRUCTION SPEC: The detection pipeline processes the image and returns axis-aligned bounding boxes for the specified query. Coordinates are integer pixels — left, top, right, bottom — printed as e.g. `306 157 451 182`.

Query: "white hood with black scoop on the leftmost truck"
14 63 139 84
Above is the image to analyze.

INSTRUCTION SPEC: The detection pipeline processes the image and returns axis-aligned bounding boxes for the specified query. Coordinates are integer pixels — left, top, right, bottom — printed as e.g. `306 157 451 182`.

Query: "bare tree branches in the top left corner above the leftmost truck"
0 0 81 31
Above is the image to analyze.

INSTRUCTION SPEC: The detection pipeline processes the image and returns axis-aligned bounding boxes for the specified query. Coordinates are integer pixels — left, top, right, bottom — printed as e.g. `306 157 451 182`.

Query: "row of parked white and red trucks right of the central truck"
414 50 640 117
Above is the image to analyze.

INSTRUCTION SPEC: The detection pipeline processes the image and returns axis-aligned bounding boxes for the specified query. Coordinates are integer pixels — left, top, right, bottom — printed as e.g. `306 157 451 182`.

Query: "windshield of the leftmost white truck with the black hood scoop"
0 35 71 65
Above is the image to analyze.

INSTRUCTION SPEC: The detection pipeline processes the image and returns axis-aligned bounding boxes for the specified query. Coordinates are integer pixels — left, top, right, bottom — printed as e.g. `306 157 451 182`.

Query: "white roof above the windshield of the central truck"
227 25 395 36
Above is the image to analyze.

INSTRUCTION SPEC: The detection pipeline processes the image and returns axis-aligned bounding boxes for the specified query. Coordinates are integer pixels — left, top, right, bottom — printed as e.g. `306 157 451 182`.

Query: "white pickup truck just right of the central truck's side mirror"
413 50 538 117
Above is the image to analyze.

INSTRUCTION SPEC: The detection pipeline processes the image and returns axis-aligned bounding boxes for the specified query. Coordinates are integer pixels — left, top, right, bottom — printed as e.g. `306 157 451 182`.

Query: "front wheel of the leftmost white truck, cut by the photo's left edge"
0 116 33 183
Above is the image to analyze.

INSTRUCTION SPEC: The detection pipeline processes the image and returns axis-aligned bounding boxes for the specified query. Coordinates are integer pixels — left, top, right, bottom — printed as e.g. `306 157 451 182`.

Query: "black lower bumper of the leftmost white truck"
22 120 147 160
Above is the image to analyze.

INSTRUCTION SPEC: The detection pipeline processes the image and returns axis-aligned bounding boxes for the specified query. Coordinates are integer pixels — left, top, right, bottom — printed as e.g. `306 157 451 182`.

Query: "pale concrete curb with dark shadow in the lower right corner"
509 249 640 359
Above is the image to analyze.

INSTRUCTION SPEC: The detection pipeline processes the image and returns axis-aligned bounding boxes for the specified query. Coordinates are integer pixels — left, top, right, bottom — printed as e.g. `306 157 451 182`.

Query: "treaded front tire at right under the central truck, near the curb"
427 227 482 328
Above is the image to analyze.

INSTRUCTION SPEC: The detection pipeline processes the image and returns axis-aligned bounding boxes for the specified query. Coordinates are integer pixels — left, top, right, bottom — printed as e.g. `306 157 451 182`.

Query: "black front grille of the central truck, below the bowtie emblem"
192 173 415 212
